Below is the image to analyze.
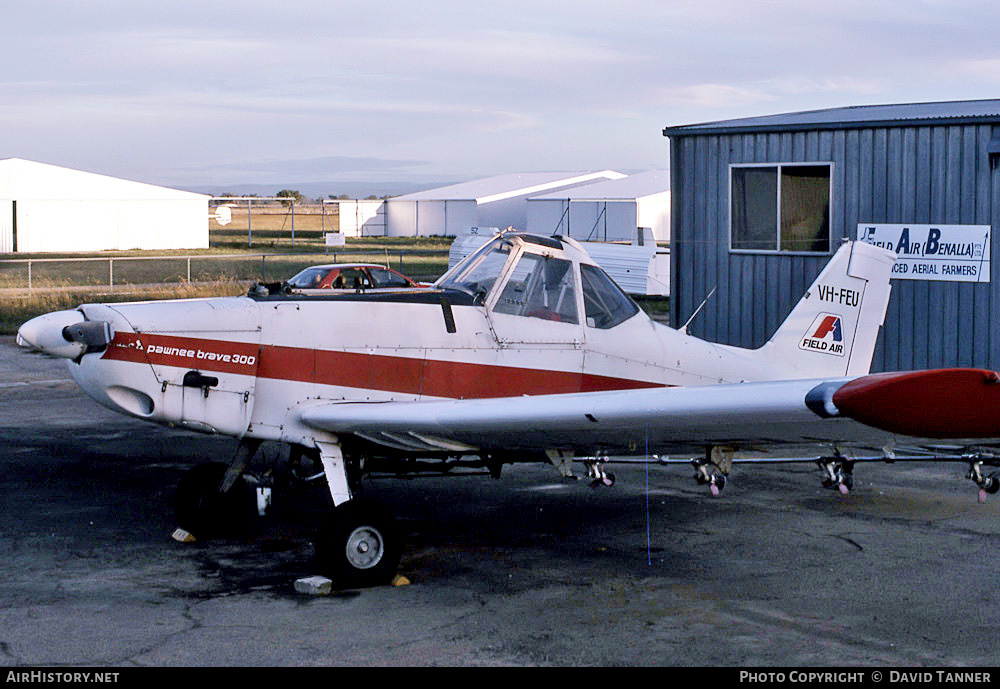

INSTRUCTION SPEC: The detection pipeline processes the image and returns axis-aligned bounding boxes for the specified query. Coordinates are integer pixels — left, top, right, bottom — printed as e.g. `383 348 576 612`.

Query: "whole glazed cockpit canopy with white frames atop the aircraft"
435 232 640 329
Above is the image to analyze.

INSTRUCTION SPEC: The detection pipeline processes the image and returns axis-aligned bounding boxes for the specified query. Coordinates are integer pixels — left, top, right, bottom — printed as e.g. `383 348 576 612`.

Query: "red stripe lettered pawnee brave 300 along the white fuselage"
102 333 662 398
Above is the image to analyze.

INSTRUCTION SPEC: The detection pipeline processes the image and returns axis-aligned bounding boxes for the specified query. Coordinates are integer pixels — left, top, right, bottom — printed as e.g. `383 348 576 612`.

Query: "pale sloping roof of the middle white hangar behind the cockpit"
390 170 625 203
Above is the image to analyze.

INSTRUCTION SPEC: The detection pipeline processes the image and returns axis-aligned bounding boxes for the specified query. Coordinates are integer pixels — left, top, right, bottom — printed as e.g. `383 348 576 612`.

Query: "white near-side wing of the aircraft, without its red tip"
301 379 887 455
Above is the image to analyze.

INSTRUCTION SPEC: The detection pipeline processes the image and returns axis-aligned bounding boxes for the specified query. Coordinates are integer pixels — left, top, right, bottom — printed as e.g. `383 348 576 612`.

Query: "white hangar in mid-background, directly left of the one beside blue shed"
339 170 625 237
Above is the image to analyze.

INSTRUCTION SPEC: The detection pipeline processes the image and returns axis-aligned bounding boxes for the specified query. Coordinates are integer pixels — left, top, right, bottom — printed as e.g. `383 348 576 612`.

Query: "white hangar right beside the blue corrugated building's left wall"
526 170 670 242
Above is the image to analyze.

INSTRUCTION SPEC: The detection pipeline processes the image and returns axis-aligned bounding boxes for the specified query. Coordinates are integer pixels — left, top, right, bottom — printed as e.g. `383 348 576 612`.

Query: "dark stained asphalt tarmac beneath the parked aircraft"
0 337 1000 668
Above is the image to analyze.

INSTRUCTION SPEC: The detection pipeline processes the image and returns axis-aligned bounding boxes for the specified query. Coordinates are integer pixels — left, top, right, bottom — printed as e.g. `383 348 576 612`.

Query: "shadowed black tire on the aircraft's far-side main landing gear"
174 462 257 540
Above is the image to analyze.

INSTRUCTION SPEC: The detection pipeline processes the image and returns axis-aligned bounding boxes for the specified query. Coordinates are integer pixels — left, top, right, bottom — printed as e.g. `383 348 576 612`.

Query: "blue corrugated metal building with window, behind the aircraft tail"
663 100 1000 370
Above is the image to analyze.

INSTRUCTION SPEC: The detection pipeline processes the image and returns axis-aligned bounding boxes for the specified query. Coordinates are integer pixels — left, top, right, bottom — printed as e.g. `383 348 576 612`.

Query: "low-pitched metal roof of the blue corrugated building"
663 99 1000 136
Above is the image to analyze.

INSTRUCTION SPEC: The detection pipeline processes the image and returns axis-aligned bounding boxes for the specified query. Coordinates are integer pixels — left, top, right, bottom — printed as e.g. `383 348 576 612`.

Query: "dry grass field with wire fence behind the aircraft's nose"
0 207 669 335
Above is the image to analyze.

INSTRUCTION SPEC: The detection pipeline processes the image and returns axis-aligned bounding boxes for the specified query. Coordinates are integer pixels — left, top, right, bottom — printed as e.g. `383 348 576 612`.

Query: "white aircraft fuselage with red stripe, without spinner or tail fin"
52 238 780 441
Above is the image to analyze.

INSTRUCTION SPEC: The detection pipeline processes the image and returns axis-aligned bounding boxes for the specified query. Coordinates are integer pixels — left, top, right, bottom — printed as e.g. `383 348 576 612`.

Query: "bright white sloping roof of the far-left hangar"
0 158 211 202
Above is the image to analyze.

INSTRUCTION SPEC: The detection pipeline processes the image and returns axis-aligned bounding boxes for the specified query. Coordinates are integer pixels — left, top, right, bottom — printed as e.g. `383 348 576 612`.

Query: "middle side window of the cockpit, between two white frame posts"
493 253 580 324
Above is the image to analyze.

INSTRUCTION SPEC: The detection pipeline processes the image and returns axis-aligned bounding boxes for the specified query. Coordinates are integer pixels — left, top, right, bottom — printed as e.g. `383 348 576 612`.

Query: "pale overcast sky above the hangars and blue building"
0 0 1000 193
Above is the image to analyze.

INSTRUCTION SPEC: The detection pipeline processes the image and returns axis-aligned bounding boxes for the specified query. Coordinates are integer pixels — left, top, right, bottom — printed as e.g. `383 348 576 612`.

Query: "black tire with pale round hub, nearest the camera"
316 499 403 588
